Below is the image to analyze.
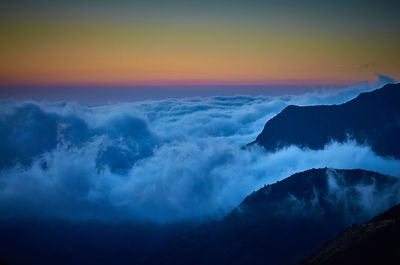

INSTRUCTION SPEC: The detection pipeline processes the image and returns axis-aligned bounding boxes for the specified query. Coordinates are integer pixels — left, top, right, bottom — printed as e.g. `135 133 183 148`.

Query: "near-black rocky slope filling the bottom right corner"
301 204 400 265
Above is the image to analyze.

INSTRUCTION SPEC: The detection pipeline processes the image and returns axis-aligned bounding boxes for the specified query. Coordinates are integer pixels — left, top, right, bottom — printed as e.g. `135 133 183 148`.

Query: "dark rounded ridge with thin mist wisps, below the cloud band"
143 168 400 264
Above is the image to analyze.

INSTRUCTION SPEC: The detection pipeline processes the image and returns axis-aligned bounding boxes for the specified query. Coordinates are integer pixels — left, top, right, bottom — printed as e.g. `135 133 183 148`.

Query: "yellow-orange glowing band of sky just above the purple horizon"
0 18 400 85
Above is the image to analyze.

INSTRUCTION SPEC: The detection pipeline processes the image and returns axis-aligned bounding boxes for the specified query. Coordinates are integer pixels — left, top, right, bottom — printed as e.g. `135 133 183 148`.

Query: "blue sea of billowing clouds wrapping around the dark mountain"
0 77 400 223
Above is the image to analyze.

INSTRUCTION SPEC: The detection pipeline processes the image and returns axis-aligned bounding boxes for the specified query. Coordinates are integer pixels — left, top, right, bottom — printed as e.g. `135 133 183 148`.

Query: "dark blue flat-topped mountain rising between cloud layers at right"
252 83 400 158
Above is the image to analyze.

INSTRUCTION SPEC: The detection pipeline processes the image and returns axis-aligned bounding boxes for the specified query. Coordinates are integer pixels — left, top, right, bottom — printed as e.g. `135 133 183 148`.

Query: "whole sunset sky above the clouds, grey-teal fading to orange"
0 0 400 96
